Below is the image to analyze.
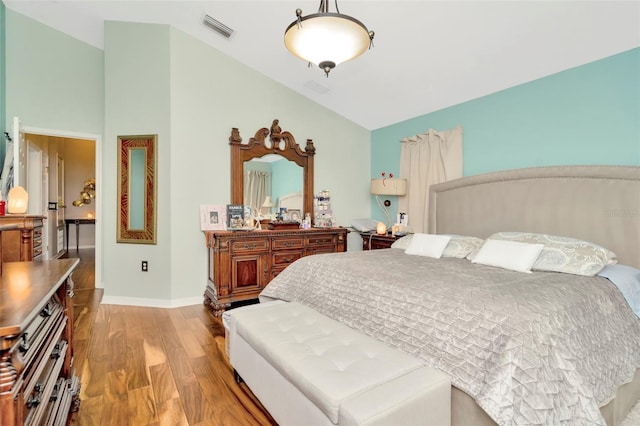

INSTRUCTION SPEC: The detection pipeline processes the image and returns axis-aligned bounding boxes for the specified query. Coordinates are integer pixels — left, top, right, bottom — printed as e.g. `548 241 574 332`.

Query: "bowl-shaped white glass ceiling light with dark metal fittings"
284 0 375 77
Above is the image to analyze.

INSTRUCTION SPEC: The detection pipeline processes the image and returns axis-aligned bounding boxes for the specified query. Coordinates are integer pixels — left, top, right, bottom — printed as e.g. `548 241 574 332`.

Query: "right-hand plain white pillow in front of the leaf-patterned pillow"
471 239 544 274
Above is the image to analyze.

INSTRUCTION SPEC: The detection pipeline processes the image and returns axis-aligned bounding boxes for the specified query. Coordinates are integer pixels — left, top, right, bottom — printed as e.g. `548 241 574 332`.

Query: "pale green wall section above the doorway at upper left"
5 9 104 134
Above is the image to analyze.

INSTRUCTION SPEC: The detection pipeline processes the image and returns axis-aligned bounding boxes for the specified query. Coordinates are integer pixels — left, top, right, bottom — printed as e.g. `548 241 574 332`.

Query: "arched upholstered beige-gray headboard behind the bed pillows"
429 166 640 268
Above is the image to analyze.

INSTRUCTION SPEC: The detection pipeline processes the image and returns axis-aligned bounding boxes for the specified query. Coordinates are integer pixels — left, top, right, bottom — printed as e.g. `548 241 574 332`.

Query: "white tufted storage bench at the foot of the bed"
223 301 451 426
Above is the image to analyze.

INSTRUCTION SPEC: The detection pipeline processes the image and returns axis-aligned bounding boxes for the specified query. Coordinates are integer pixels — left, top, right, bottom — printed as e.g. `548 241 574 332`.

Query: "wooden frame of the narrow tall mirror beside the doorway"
117 135 158 244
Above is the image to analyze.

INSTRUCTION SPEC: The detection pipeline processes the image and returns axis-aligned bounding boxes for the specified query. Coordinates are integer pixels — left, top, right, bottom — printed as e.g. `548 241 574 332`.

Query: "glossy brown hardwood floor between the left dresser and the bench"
63 249 276 426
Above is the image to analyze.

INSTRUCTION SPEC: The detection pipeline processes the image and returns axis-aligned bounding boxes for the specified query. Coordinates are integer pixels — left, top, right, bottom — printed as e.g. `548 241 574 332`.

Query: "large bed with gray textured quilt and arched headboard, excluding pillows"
260 166 640 425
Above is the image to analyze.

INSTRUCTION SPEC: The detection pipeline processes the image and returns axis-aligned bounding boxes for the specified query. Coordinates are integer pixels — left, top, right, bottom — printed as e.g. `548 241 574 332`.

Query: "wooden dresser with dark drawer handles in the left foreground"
0 258 80 426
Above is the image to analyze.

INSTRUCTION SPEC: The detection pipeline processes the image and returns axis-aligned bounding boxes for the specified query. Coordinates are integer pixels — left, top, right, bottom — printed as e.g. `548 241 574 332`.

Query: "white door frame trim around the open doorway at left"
22 126 104 288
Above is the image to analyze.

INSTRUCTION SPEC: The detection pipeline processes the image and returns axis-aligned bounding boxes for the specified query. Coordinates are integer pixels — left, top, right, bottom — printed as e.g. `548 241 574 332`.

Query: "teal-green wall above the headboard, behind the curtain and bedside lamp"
371 48 640 223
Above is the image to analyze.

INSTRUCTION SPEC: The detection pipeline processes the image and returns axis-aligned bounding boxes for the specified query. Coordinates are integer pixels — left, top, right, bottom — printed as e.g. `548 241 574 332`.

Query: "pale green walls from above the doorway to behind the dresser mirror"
3 9 370 306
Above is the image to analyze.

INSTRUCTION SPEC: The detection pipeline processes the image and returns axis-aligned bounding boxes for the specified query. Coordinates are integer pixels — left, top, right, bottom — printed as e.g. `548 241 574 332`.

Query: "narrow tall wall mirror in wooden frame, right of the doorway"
117 135 158 244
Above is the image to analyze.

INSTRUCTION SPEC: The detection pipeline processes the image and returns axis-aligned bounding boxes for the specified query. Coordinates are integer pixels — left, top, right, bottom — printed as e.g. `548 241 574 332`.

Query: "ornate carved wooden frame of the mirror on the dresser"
229 119 316 218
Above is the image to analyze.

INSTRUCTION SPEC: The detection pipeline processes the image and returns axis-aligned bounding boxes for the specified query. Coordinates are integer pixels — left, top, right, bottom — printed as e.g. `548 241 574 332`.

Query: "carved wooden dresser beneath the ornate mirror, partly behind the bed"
204 228 349 316
